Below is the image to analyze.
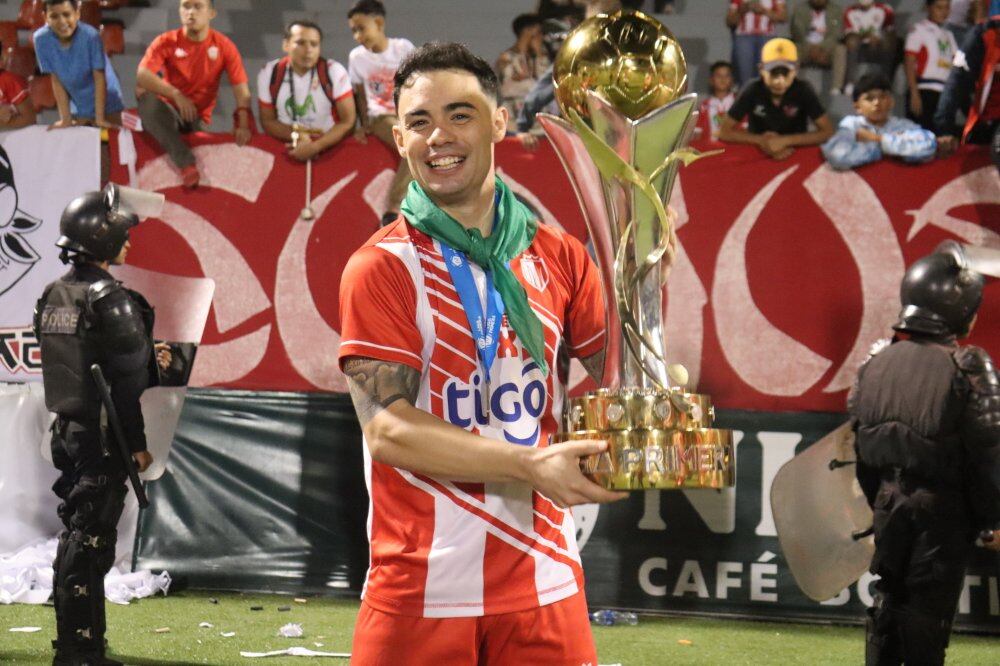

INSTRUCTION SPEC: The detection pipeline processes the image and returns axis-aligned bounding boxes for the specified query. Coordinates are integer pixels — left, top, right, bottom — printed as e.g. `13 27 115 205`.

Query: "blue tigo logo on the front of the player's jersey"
444 362 546 446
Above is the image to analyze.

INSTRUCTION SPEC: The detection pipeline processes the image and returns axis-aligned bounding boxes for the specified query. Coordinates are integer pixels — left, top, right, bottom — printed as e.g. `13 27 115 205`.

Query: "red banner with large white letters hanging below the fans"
112 134 1000 411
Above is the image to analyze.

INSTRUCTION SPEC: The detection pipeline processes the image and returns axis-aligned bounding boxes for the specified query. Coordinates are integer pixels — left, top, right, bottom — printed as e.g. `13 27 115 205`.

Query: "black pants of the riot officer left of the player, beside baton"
52 419 127 662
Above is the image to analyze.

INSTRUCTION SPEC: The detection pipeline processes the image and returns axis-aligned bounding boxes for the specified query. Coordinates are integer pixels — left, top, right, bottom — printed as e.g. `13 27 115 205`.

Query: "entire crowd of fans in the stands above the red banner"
0 0 1000 193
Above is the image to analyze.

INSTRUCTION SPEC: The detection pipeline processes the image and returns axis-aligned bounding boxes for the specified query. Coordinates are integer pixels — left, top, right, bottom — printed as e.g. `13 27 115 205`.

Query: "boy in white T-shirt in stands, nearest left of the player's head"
347 0 414 224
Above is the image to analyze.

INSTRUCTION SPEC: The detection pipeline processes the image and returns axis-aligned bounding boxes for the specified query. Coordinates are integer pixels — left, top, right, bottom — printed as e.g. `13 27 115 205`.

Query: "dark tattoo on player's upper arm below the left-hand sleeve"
344 357 420 428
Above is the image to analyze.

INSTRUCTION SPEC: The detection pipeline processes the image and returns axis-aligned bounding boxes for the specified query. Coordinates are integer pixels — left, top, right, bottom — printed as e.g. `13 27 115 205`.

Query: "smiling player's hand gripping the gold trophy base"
528 439 628 508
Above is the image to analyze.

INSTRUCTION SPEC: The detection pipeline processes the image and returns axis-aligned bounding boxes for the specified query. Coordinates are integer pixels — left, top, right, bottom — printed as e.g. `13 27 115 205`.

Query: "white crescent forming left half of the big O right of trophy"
712 166 832 395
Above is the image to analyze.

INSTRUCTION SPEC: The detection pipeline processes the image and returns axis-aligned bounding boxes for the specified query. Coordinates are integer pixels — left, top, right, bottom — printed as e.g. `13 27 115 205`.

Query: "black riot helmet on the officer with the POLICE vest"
56 184 139 263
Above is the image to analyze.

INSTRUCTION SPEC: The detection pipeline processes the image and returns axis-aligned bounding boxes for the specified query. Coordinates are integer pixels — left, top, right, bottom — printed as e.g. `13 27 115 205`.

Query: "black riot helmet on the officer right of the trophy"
893 241 984 336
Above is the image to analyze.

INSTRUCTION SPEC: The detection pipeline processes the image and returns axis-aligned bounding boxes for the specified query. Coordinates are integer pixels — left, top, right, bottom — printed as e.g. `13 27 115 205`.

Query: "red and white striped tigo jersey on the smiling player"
340 218 605 617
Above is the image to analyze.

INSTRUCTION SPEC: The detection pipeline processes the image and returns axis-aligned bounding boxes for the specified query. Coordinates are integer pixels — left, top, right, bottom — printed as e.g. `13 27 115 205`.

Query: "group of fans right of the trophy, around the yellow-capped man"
720 0 1000 169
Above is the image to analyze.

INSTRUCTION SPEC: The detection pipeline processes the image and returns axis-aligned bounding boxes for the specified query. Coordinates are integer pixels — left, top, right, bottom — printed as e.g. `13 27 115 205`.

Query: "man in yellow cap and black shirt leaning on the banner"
719 37 833 160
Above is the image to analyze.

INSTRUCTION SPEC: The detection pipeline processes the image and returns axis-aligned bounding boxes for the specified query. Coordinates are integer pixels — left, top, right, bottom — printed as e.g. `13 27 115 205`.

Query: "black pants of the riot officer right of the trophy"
865 481 973 666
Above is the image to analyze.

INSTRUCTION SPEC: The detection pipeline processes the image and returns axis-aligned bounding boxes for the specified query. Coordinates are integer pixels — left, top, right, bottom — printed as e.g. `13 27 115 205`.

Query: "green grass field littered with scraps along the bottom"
0 592 1000 666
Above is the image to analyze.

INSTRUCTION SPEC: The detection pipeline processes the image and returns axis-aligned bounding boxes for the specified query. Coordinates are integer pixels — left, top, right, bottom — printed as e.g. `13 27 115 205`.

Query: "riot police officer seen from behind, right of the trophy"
848 241 1000 665
